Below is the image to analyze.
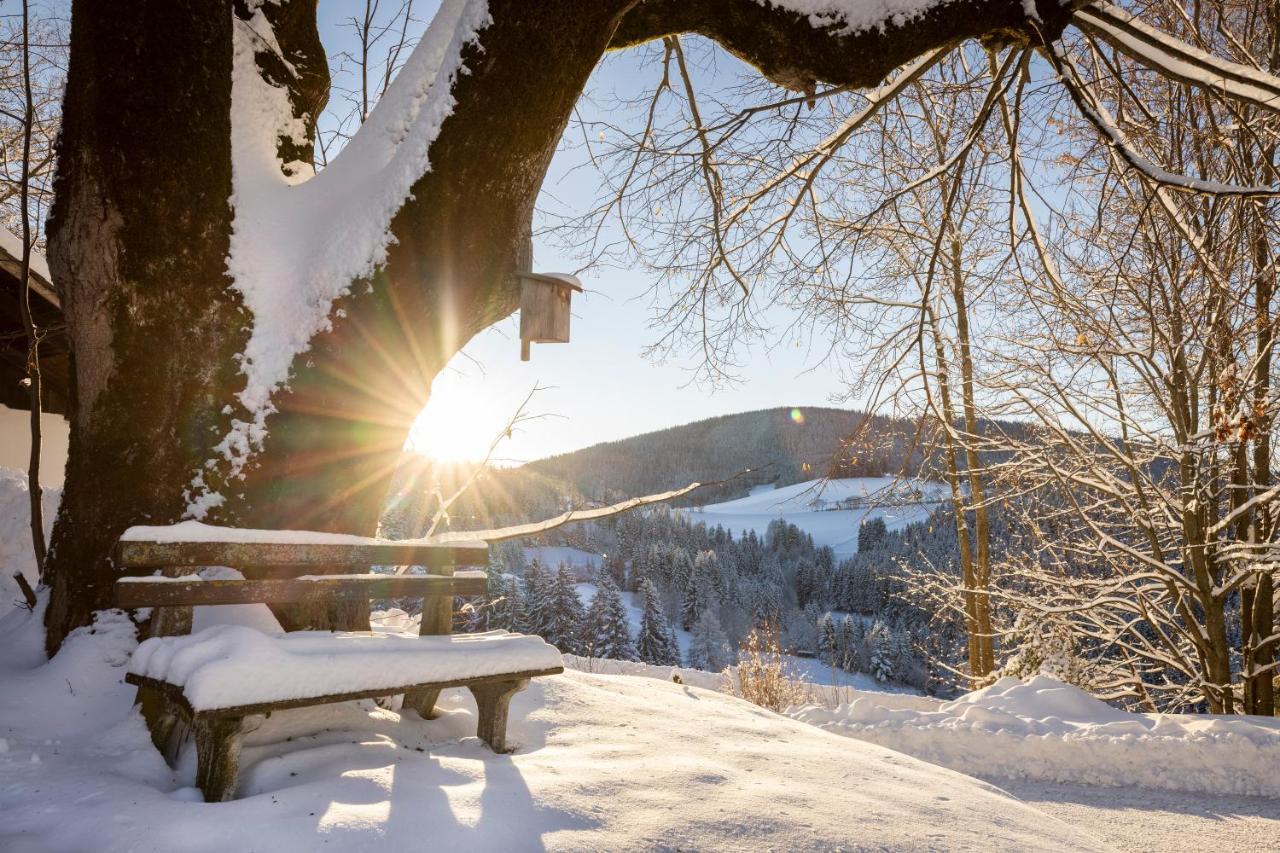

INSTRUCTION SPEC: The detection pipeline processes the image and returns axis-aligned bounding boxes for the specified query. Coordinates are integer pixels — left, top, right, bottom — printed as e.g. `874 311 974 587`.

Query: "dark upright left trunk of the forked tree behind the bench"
45 0 248 651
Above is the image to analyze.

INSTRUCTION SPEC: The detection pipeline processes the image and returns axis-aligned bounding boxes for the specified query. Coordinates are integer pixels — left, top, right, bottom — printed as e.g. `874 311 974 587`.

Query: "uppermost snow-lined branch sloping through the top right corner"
1074 3 1280 113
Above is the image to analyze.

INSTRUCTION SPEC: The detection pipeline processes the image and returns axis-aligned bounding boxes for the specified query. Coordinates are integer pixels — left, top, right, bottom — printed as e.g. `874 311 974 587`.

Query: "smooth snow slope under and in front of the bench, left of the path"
0 596 1105 853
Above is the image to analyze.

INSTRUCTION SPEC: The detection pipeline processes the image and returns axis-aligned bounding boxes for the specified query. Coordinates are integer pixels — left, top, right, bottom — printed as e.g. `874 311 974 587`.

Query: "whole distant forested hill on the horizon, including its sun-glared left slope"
384 407 920 527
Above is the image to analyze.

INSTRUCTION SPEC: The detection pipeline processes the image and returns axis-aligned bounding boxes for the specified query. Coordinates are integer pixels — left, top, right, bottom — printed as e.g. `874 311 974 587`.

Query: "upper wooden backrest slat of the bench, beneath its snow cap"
115 540 489 574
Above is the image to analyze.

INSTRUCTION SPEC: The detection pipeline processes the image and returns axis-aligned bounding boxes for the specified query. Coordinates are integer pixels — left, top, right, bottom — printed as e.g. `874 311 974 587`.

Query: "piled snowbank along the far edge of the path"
790 675 1280 797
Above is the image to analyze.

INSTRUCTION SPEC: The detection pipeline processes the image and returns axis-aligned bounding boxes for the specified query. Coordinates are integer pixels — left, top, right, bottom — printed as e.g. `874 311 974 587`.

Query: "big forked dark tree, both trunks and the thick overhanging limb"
46 0 1079 651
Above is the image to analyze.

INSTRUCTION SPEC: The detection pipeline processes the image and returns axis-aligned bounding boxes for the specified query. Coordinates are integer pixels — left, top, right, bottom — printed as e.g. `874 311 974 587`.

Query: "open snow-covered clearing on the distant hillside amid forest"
681 476 946 560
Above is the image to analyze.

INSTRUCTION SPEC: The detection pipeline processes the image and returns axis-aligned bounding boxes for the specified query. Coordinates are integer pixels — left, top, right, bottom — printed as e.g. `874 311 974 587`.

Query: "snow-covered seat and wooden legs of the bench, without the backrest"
125 625 564 802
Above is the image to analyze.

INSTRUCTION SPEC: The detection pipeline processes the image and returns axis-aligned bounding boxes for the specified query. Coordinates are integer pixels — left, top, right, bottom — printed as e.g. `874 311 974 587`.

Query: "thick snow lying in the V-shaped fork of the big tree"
187 0 489 519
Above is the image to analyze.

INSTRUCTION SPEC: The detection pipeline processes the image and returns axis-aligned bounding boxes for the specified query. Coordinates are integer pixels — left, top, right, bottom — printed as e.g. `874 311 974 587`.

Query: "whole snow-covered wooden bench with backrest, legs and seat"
115 523 563 802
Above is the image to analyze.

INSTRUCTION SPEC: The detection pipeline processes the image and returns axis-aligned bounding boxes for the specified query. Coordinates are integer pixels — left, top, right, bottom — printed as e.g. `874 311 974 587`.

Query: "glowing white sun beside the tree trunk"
406 370 506 462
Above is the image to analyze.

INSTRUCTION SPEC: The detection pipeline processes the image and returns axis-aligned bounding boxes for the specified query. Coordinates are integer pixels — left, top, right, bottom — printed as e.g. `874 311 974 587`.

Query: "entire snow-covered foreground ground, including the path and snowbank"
10 471 1280 853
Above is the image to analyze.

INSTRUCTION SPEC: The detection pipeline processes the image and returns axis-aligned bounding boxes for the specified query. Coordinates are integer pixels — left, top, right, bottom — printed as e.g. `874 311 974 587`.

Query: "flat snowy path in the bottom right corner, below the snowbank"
992 780 1280 853
